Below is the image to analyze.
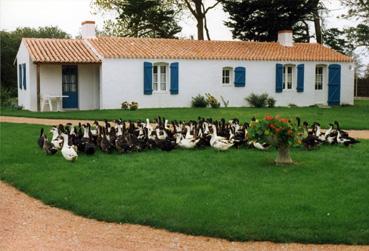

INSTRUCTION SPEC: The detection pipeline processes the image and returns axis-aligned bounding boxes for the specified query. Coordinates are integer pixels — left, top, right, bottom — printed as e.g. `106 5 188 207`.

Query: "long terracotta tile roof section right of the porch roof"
88 37 352 62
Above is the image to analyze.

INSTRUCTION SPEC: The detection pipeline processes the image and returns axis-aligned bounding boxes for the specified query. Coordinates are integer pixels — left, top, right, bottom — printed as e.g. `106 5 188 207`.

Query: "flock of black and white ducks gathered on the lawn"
38 117 359 161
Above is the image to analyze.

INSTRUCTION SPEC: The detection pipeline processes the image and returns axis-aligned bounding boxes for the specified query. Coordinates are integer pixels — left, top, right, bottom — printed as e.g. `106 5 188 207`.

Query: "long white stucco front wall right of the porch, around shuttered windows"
100 59 354 109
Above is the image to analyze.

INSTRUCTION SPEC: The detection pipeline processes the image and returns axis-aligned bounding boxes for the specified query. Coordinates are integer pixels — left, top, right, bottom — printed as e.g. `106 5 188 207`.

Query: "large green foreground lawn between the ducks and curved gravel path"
0 123 369 244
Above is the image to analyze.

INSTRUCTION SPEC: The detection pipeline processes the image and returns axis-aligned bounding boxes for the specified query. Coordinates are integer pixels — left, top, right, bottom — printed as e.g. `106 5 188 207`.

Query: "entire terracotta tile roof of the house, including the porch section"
24 37 352 63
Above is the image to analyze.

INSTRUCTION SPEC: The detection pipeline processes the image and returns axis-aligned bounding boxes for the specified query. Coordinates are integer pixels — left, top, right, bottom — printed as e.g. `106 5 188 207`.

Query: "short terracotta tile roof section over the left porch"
24 38 101 63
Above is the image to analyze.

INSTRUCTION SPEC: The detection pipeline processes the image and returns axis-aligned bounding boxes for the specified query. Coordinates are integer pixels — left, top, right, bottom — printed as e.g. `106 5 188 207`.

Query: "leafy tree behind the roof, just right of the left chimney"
93 0 182 38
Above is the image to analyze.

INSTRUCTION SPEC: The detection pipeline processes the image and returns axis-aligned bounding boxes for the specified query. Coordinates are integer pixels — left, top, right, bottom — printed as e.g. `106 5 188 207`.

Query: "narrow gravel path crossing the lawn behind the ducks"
0 116 369 139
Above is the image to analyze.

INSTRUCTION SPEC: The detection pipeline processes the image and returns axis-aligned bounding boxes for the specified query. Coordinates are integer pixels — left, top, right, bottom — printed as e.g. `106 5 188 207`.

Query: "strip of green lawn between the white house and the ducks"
0 100 369 129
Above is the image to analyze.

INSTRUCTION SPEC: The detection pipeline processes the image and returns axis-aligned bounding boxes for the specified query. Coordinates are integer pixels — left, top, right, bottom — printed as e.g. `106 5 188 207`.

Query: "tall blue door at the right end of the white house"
328 64 341 105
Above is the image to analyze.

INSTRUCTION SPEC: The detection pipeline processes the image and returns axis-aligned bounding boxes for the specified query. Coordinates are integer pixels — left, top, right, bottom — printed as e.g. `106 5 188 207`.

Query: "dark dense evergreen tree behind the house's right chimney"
223 0 319 42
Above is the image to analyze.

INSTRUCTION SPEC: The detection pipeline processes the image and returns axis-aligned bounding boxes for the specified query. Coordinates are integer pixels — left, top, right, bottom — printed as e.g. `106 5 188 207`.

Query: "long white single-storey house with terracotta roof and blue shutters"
17 21 354 111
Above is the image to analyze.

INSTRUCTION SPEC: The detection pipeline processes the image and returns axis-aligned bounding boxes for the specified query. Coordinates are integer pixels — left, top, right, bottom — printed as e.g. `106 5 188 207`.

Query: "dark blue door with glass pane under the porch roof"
62 65 78 108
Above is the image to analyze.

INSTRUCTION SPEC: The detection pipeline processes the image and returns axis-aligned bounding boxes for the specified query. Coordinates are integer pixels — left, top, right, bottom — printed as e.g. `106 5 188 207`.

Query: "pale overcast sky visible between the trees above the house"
0 0 369 68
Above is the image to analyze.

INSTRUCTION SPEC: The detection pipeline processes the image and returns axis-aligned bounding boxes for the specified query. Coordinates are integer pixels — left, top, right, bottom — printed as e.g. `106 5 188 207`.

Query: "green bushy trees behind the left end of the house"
0 26 70 97
